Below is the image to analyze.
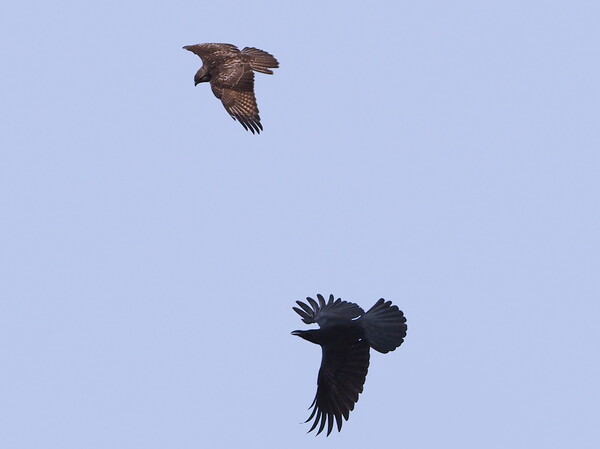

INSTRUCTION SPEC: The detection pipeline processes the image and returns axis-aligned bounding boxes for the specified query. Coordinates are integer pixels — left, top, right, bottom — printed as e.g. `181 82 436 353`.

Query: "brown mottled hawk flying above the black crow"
183 44 279 134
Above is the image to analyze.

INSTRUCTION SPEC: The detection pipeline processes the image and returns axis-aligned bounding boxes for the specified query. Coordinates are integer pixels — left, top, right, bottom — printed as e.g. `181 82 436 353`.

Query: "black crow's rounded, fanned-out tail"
361 299 407 354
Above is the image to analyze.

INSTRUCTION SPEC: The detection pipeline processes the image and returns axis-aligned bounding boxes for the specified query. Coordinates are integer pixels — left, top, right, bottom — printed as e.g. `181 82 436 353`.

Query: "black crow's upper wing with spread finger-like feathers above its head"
293 295 365 327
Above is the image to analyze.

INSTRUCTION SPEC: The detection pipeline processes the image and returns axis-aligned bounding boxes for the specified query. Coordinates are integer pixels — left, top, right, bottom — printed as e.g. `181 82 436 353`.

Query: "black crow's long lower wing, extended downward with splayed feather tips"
306 340 369 435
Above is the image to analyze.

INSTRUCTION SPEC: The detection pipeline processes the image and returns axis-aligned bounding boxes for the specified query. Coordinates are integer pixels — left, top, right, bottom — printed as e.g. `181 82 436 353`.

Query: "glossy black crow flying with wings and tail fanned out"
292 295 407 436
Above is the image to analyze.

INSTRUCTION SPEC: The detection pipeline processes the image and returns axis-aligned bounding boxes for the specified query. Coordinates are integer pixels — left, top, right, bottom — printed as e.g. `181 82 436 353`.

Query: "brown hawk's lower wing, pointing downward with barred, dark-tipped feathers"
210 60 262 134
